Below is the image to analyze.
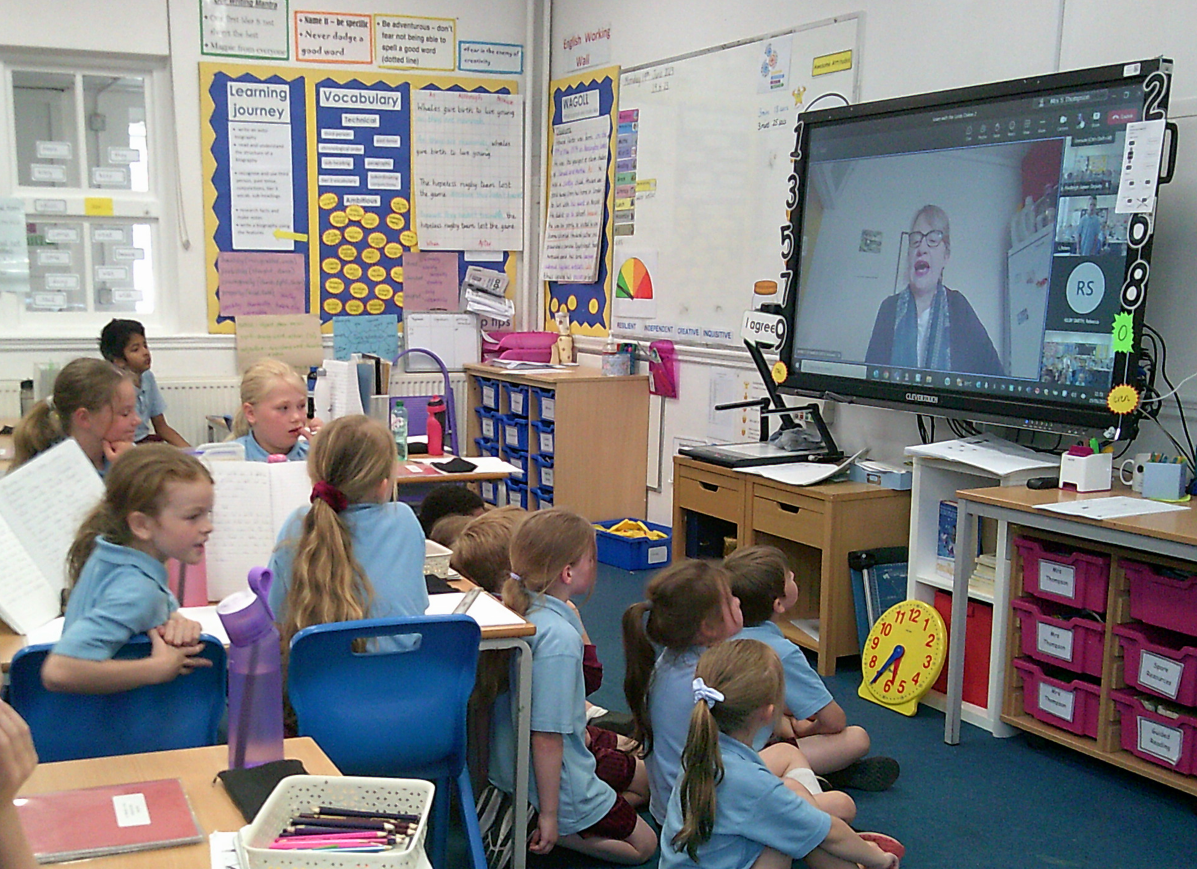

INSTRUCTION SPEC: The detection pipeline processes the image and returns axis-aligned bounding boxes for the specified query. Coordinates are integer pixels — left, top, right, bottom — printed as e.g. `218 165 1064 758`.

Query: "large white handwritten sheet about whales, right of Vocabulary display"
413 91 523 250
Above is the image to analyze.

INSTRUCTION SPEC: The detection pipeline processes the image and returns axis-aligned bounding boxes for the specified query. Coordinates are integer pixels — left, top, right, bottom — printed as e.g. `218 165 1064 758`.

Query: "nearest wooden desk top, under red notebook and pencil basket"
18 736 340 869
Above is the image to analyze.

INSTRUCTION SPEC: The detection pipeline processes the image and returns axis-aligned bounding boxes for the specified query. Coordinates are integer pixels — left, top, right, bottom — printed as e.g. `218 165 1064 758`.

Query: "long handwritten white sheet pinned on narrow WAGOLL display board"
541 115 610 284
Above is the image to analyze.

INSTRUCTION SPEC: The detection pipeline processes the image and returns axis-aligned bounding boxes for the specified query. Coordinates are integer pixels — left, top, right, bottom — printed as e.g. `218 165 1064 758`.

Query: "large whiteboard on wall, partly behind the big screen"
612 16 861 346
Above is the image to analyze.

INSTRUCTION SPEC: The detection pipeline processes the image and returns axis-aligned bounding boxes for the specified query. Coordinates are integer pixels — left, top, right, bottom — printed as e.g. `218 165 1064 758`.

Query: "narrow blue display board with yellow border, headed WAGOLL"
541 67 619 336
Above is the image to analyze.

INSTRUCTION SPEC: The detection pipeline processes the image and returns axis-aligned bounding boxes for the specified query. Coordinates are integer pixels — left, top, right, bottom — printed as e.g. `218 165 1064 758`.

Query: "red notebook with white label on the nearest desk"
13 778 203 863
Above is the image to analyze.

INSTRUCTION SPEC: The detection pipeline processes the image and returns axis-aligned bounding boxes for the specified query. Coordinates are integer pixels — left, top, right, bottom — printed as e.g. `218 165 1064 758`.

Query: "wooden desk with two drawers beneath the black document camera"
673 456 910 676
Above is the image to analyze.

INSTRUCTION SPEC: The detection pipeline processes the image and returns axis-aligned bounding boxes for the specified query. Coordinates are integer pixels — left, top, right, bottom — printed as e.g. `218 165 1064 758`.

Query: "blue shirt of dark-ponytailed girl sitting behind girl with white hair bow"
644 645 706 824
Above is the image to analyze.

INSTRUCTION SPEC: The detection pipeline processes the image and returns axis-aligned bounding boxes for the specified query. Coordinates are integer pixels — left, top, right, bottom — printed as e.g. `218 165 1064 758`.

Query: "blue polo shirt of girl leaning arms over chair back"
54 536 178 661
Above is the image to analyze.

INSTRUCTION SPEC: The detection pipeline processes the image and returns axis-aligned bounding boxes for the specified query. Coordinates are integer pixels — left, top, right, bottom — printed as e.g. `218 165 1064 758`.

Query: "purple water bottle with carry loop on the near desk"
217 567 282 770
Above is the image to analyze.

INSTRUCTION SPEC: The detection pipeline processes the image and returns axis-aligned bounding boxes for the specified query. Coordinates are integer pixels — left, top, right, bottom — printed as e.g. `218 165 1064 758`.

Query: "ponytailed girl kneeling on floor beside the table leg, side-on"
491 508 657 864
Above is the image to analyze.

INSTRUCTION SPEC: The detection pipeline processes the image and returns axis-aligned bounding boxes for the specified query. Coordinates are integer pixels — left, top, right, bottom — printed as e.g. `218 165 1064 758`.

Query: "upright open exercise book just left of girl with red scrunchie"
206 462 311 601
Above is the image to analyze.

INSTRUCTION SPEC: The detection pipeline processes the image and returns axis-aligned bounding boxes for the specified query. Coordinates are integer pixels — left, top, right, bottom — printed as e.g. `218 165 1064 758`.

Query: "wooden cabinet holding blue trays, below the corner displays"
463 365 649 522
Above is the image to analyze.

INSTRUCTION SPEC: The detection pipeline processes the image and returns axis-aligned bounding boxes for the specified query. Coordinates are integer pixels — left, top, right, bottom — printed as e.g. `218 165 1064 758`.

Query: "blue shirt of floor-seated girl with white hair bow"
660 734 831 869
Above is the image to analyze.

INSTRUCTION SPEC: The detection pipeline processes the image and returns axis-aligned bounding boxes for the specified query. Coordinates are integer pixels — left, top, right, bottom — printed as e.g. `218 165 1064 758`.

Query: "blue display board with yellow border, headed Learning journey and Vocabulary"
200 63 522 333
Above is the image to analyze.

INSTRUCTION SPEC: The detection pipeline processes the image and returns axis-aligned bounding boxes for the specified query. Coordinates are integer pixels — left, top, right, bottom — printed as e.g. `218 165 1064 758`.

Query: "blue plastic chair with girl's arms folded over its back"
8 634 229 762
